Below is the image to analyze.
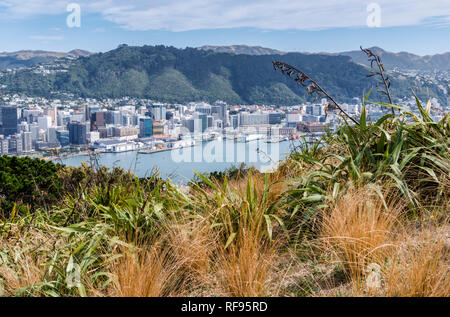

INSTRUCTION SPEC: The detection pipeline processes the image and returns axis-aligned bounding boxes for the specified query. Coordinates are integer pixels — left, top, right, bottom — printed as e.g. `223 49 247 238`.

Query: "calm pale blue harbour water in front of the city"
55 140 298 183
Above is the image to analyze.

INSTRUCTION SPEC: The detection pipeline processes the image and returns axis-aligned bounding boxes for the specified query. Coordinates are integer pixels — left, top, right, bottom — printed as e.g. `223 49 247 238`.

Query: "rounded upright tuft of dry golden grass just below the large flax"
322 185 399 281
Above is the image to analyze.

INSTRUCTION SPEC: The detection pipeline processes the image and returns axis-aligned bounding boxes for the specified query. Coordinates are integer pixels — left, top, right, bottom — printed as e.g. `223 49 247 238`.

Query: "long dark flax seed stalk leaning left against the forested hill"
272 61 359 125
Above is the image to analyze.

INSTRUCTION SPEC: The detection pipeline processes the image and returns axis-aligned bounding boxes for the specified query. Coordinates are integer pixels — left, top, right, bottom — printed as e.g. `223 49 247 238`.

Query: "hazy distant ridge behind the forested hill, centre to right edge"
199 45 450 71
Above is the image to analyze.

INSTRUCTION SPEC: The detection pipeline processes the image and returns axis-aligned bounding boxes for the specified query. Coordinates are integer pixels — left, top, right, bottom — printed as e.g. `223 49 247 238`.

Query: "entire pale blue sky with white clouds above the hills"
0 0 450 55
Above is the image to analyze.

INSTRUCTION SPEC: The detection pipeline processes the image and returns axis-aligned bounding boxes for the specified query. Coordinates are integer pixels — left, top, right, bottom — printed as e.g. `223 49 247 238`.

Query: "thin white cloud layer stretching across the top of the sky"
0 0 450 31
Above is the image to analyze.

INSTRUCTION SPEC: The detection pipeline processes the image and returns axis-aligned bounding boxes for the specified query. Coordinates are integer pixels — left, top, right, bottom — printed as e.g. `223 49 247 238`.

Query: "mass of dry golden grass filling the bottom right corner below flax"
322 189 450 297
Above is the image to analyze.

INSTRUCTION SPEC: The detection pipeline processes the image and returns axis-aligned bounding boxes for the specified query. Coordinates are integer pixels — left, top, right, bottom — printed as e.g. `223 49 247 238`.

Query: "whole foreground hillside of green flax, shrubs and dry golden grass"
0 92 450 296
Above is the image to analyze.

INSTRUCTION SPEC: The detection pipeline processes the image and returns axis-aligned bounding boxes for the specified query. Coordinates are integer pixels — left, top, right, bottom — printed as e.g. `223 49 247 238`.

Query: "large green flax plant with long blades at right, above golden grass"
282 90 450 236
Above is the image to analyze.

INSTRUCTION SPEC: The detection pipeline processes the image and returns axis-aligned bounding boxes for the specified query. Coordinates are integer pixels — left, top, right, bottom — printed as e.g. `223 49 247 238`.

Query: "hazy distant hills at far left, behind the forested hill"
0 49 92 70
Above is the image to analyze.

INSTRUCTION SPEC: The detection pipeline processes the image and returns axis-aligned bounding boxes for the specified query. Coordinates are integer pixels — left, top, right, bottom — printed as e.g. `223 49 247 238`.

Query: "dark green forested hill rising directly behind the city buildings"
0 45 445 105
